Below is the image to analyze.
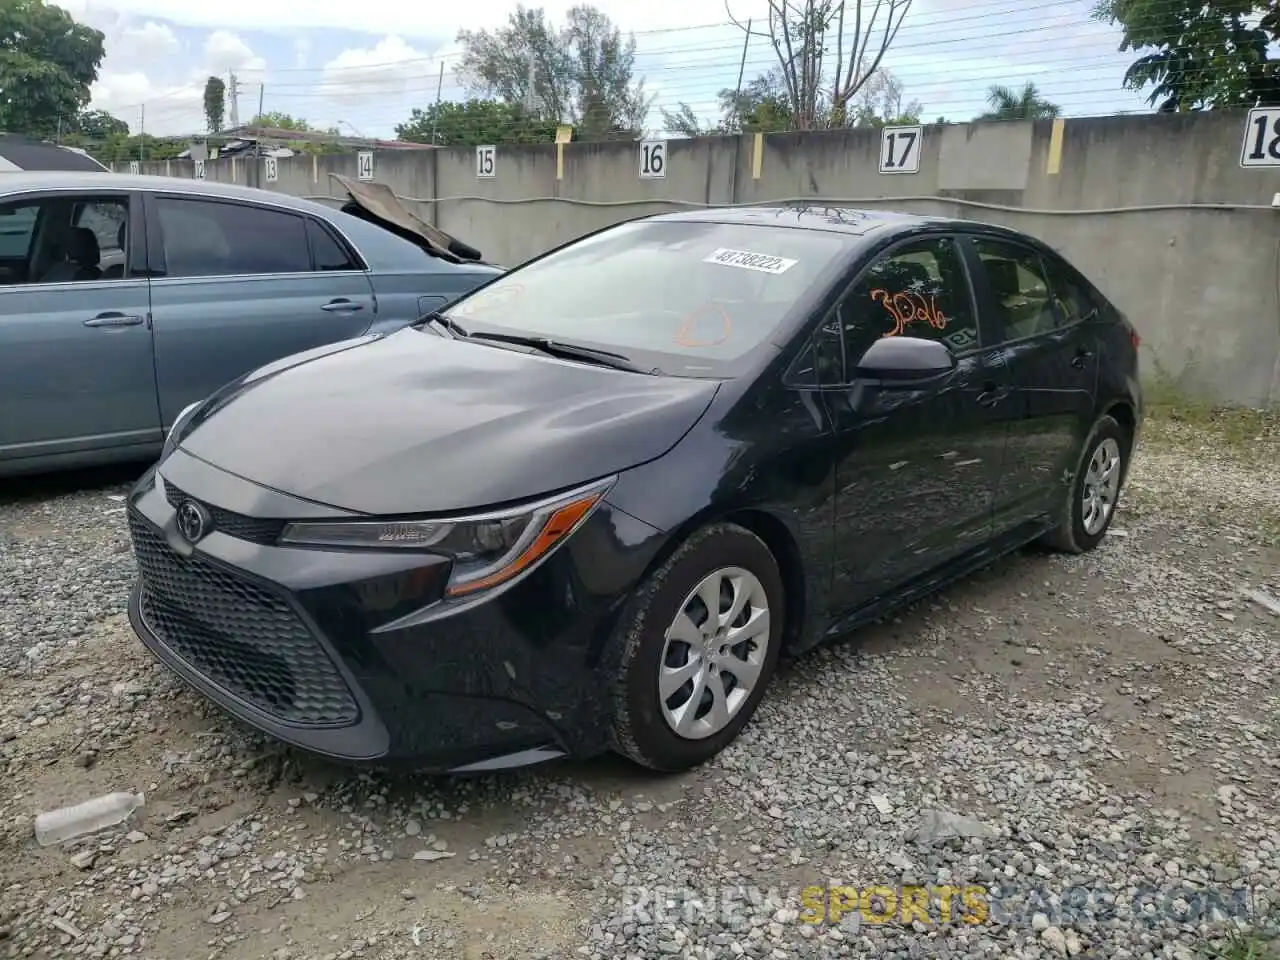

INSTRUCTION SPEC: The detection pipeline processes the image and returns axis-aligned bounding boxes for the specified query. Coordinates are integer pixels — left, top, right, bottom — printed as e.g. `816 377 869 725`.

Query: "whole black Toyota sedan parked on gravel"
129 207 1142 772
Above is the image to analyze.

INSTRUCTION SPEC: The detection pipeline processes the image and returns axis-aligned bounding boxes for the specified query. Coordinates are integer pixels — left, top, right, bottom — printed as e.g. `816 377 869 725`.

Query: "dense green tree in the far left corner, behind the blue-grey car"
0 0 105 137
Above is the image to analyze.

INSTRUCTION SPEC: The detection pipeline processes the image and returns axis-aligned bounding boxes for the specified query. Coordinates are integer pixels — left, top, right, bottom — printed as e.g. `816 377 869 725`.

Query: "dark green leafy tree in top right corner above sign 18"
1093 0 1280 113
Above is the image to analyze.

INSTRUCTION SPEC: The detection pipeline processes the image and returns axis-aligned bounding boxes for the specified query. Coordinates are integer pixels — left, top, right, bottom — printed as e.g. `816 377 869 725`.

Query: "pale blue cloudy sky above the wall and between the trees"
59 0 1149 137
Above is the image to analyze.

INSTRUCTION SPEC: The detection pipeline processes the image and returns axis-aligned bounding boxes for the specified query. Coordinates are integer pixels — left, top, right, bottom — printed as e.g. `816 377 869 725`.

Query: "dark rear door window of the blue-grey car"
156 197 311 276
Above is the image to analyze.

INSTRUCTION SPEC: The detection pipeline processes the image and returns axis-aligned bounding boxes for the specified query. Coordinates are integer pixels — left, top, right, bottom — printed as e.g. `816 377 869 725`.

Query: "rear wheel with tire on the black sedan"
1043 416 1130 553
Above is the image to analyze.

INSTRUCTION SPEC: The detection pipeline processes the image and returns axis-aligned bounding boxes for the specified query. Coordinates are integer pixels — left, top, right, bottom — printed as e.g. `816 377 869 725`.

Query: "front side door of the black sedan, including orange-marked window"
824 236 1012 611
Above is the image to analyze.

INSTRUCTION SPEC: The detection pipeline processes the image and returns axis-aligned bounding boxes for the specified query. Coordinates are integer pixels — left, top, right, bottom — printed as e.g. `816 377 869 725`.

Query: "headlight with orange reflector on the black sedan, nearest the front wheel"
280 477 614 596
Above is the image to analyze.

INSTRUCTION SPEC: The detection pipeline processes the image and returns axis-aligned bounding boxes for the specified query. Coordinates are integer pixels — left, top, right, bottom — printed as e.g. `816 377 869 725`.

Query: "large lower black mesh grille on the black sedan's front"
129 511 360 726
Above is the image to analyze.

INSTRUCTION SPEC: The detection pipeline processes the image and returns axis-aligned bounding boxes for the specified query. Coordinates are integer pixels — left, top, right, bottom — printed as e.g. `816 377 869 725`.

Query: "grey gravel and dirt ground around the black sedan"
0 424 1280 960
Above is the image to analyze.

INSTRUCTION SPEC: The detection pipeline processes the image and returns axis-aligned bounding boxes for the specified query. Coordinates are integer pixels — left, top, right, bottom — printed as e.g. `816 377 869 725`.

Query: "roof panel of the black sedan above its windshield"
645 201 1025 248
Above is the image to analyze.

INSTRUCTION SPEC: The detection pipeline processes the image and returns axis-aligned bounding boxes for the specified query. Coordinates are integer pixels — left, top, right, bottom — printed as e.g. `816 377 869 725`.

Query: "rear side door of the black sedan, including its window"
964 234 1098 536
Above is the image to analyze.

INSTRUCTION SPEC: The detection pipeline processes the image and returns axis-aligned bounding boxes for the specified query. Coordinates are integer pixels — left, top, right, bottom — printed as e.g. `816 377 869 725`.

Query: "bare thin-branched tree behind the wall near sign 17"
726 0 911 131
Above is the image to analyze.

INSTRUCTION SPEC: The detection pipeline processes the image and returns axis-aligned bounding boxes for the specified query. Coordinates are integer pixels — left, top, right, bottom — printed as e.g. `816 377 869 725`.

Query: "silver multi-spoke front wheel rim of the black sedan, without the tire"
658 567 769 740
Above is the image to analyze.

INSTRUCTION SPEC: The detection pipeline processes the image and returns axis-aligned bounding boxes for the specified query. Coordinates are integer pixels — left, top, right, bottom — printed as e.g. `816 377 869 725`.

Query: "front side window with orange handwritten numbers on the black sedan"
837 237 978 365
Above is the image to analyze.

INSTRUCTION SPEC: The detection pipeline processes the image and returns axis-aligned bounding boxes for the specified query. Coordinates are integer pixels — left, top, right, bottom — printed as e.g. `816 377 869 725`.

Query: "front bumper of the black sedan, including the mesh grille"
128 451 663 772
